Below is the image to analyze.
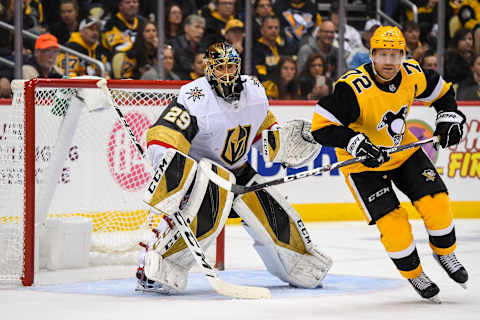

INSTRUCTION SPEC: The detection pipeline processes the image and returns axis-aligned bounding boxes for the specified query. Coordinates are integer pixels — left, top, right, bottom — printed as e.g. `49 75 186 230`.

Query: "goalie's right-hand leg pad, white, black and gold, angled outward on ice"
233 176 332 288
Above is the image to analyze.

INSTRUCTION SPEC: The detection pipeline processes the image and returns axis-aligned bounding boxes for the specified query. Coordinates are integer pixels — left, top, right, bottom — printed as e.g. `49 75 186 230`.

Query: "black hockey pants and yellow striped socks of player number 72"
345 148 456 278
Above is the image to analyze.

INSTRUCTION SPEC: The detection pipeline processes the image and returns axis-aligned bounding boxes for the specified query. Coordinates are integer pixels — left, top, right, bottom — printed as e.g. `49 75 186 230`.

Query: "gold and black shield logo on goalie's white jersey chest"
221 125 252 165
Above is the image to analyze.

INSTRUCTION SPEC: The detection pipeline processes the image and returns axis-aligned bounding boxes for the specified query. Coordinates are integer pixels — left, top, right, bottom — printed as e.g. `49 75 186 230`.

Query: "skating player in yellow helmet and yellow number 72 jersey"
312 26 468 300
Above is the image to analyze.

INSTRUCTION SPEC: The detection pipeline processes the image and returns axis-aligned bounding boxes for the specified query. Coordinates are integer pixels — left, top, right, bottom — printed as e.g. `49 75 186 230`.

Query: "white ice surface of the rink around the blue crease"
0 219 480 320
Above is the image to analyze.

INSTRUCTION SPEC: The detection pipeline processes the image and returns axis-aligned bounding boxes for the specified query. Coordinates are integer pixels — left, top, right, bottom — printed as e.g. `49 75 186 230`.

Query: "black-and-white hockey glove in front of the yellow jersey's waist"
347 133 390 168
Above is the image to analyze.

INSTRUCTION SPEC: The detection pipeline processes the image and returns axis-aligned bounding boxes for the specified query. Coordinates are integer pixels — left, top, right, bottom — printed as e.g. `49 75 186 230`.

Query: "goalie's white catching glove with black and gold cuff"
262 119 322 167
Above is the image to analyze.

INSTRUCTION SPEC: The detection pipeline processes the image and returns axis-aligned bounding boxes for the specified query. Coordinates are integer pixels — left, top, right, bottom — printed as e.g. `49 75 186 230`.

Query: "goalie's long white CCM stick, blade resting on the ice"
97 79 271 299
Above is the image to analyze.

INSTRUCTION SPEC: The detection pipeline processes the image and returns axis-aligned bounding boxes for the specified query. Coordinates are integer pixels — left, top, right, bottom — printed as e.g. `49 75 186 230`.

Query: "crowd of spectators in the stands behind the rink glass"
0 0 480 100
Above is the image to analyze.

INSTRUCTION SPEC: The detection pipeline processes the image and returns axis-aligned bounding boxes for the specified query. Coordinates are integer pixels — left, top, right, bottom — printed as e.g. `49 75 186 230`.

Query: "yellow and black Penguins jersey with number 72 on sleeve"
312 59 457 173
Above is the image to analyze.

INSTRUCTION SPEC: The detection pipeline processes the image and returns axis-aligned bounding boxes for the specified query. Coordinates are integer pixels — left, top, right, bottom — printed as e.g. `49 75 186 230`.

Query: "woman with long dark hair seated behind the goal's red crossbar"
117 22 158 79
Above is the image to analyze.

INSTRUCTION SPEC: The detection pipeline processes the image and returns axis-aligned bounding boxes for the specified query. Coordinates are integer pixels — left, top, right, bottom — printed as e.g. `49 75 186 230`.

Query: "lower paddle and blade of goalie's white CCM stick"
173 211 272 299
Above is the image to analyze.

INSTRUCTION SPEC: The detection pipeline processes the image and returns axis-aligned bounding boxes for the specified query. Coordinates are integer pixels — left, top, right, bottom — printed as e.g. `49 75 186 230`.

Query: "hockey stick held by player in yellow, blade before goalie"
200 137 438 194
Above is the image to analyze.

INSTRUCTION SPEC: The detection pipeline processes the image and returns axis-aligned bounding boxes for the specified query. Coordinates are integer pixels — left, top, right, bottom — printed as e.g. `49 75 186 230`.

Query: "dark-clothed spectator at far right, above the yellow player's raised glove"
444 28 473 83
